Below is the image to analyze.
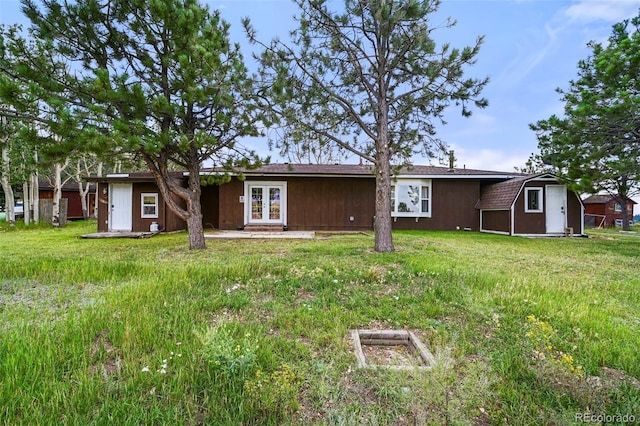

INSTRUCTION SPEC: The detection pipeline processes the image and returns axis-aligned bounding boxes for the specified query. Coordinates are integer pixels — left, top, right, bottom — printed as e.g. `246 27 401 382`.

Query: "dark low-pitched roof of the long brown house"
202 163 521 179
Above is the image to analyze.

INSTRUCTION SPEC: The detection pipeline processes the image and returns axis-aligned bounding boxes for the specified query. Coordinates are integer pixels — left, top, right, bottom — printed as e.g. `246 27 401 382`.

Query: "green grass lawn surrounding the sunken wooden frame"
0 222 640 425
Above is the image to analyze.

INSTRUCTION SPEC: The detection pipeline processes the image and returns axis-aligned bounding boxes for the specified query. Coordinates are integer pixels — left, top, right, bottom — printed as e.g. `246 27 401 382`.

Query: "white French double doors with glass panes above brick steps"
245 182 287 225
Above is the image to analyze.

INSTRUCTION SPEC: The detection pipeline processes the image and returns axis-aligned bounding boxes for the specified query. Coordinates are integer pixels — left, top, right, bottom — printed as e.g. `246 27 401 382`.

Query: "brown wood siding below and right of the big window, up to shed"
393 179 480 231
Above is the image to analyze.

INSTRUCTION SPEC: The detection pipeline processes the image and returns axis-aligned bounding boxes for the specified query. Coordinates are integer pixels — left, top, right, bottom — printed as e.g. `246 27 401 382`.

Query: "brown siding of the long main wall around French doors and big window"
219 177 480 230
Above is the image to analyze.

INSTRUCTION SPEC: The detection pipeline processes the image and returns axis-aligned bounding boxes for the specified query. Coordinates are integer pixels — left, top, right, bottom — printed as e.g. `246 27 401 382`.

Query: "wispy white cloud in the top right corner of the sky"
564 0 640 23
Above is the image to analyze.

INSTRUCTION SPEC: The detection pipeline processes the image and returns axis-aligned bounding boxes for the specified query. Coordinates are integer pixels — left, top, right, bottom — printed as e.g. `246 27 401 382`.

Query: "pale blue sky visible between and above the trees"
0 0 640 176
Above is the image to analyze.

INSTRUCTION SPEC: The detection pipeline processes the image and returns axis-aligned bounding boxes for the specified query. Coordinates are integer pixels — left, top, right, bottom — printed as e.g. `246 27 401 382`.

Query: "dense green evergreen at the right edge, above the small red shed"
531 12 640 229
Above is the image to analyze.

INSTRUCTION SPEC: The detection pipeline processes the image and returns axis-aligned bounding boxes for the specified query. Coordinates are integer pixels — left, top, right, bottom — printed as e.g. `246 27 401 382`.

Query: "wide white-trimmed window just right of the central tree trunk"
391 179 431 217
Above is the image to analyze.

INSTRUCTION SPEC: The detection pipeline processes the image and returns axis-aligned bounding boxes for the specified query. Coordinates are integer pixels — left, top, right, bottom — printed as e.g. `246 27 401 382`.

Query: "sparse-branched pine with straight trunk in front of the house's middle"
246 0 488 252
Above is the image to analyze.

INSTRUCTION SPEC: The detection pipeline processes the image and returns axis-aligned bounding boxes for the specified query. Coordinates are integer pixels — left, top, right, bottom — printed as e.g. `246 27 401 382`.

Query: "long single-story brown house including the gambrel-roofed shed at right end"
90 164 583 235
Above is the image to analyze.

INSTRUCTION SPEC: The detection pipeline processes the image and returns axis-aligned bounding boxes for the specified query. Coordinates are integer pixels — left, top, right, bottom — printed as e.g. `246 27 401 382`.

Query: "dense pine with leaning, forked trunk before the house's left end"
1 0 259 249
